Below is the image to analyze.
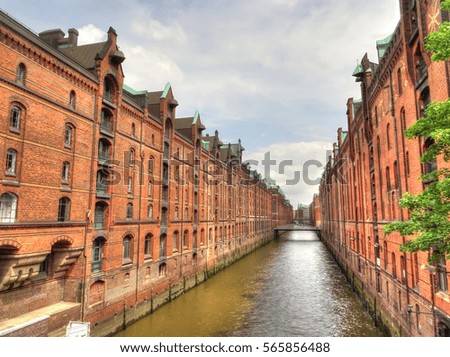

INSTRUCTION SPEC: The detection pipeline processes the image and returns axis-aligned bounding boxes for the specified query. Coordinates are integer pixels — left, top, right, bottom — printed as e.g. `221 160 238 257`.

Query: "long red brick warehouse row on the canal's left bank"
0 12 292 336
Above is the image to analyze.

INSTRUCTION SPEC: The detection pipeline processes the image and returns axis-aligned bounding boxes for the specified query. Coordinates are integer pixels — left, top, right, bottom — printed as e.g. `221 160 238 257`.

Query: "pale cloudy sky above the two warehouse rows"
1 0 400 206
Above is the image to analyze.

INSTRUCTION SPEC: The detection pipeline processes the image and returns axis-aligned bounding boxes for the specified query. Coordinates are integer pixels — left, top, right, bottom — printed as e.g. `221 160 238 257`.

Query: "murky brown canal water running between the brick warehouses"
116 232 381 337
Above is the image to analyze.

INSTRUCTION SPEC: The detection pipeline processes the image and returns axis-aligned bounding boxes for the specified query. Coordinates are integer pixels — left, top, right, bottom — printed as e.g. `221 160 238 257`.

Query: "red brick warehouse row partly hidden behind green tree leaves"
310 0 450 336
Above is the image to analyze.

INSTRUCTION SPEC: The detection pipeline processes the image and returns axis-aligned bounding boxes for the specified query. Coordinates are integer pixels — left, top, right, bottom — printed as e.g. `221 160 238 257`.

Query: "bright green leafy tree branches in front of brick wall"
385 0 450 261
